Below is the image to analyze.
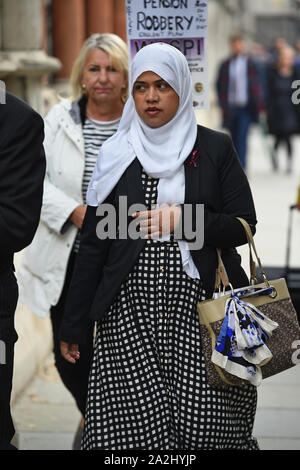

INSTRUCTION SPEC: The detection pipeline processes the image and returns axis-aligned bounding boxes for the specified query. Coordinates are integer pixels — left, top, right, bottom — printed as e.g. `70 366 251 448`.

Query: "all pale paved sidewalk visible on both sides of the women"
12 129 300 450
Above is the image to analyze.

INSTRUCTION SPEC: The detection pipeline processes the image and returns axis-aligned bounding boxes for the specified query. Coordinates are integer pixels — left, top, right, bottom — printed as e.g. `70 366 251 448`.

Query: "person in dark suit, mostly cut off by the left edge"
0 93 46 450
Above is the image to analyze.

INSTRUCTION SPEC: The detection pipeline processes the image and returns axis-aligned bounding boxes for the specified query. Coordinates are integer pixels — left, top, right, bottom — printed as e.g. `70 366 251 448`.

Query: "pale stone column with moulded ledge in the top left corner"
0 0 60 114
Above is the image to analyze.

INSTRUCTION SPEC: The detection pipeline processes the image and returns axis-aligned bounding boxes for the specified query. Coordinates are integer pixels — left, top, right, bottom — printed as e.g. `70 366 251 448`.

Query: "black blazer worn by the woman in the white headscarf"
60 126 256 344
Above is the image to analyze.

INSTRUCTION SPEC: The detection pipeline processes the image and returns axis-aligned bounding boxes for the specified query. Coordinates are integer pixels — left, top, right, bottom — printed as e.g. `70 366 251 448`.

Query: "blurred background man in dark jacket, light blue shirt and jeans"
216 36 265 169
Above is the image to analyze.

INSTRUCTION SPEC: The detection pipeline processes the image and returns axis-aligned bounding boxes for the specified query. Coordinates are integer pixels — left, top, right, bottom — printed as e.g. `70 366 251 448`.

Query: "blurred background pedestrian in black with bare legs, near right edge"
267 47 300 173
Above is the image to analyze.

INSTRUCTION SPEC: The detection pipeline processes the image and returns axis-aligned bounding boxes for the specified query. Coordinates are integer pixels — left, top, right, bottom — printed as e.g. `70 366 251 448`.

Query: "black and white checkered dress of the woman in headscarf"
82 173 258 450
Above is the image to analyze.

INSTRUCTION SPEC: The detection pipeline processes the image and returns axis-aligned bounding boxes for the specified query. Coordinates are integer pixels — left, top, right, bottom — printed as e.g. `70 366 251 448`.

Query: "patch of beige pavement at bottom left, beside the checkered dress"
12 354 81 450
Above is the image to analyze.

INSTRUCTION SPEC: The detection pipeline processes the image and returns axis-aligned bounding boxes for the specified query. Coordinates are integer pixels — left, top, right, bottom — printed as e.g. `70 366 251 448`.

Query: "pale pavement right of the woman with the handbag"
244 129 300 450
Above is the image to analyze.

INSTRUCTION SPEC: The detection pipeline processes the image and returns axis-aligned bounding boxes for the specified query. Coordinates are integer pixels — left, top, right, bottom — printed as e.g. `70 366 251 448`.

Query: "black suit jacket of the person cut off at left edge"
0 93 46 273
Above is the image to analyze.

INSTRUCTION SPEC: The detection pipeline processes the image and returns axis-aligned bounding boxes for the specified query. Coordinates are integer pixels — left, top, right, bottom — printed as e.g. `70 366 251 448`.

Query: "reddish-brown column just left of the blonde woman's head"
52 0 86 79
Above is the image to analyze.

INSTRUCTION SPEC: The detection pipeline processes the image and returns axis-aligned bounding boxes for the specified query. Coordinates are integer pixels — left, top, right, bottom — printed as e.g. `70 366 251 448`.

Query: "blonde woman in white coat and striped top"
18 34 128 448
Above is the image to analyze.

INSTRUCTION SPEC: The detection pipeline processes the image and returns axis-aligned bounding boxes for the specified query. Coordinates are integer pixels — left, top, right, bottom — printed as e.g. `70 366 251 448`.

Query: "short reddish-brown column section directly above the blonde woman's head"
86 0 114 36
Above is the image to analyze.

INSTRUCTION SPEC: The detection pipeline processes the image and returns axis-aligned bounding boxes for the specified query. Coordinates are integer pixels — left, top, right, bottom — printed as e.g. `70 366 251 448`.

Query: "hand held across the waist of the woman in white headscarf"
132 206 181 238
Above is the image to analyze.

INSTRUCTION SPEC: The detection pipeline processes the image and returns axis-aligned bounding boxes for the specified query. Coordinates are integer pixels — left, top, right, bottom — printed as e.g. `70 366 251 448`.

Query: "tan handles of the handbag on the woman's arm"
215 217 270 291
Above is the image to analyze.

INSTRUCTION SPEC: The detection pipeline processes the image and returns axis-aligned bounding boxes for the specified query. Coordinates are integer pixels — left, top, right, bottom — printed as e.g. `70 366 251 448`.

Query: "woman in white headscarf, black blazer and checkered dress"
61 43 257 450
